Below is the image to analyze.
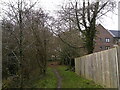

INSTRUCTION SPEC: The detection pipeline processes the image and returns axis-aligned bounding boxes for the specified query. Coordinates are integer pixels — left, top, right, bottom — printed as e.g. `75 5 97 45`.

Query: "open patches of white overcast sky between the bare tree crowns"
0 0 120 30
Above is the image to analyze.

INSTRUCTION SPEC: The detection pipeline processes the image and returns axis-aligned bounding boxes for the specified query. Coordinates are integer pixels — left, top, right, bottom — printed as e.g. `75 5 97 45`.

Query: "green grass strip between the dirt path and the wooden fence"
57 66 102 88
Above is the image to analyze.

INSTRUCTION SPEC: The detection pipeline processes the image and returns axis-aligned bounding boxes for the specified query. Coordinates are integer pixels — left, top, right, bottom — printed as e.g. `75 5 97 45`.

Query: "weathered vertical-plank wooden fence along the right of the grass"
75 47 120 88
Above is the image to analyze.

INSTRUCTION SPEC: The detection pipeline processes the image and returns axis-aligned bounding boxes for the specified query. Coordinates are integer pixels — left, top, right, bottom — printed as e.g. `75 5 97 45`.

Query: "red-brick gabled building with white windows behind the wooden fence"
94 24 120 52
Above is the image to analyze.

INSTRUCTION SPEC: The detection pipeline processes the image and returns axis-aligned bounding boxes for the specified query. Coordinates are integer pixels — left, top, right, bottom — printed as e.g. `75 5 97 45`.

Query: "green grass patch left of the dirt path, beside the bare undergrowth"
33 68 57 88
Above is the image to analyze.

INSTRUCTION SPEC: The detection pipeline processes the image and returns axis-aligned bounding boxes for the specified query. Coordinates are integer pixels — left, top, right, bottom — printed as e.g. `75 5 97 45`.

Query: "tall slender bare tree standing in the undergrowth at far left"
3 0 46 88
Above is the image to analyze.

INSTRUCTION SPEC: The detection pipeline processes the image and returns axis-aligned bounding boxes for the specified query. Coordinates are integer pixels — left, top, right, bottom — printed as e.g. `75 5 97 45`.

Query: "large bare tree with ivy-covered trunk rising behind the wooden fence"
59 0 115 54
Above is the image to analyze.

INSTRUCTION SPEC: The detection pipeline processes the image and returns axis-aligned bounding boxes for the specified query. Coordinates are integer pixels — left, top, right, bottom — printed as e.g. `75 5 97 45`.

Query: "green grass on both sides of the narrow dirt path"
27 66 103 88
